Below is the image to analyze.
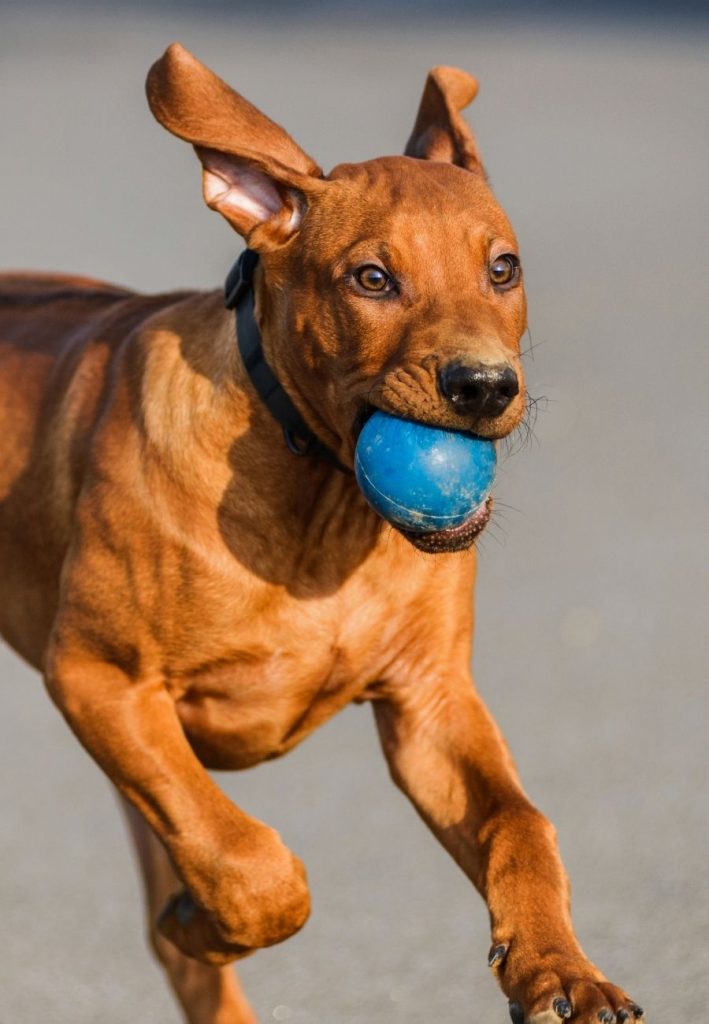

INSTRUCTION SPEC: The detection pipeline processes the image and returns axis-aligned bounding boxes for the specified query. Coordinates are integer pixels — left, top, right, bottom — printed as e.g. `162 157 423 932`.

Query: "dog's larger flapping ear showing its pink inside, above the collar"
145 43 325 249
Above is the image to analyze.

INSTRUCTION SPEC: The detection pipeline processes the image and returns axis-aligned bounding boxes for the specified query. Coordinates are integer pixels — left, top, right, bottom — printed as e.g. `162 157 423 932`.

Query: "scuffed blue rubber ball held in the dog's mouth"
355 412 497 532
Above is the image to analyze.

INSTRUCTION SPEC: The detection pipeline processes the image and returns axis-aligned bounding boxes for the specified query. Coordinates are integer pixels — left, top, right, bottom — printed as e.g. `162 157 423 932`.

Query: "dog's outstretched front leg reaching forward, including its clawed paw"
374 672 641 1024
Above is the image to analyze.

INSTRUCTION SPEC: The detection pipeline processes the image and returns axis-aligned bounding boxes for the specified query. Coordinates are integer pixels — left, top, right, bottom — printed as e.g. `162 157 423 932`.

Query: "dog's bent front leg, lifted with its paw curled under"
46 647 309 964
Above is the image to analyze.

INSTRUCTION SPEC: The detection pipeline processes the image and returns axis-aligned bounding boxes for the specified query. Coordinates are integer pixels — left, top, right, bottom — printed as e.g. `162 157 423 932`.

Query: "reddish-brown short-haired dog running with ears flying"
0 45 641 1024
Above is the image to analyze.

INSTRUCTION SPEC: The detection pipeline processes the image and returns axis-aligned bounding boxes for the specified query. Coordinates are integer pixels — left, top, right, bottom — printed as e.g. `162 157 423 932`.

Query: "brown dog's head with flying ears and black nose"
148 44 526 479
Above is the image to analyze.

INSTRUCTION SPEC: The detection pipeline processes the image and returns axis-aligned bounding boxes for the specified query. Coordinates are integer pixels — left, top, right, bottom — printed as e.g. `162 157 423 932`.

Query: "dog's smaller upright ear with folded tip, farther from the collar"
405 67 484 173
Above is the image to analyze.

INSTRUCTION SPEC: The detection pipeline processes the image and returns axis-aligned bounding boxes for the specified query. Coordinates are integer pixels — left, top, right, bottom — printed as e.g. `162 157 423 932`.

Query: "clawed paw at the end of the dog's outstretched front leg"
490 945 645 1024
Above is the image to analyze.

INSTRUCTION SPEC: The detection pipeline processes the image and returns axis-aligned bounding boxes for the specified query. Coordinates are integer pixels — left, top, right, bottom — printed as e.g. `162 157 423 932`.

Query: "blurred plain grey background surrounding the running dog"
0 0 709 1024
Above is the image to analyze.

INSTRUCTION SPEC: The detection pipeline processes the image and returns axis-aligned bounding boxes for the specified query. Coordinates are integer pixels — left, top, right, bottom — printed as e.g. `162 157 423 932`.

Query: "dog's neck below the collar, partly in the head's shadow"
142 292 387 592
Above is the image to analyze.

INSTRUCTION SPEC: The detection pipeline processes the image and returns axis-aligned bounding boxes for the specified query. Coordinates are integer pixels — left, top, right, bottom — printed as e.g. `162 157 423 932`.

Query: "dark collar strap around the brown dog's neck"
224 249 351 473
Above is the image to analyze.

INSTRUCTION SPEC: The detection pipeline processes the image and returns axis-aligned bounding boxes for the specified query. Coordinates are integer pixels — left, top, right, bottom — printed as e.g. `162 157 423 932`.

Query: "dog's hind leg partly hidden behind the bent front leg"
121 800 257 1024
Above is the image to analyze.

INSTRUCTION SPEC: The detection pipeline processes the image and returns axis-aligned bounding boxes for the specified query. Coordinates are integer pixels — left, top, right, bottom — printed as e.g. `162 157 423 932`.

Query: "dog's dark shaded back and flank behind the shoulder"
0 273 191 668
